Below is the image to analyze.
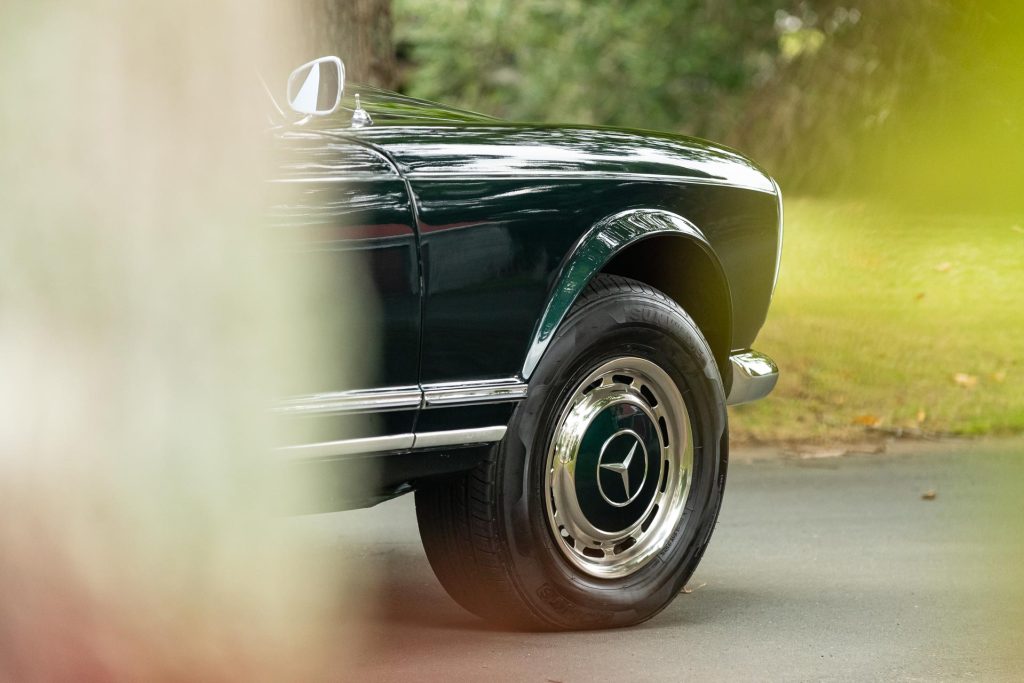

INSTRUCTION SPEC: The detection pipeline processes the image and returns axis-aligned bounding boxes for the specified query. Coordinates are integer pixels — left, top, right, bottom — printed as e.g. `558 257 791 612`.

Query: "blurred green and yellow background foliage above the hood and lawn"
394 0 1024 204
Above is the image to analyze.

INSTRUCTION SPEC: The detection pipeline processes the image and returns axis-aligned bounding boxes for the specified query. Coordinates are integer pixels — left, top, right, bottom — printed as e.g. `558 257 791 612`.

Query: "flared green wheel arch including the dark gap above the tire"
522 209 732 390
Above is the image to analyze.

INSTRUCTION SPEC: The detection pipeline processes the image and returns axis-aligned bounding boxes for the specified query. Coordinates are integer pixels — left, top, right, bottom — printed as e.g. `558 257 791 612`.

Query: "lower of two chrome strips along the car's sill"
280 426 508 460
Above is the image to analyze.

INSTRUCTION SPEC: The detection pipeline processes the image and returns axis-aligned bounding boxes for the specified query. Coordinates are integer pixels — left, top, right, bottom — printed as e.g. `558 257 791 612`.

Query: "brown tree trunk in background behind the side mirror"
302 0 396 88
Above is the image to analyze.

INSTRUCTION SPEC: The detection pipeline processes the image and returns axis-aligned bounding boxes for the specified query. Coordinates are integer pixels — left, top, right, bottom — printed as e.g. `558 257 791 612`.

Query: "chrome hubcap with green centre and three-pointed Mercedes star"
546 357 693 579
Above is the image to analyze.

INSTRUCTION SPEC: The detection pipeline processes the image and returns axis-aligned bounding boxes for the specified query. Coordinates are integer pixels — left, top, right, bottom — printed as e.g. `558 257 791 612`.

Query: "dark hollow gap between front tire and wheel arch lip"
601 236 732 390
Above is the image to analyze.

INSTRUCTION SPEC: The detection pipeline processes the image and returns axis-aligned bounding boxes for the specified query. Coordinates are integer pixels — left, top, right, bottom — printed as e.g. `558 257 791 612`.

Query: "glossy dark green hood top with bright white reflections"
305 85 778 194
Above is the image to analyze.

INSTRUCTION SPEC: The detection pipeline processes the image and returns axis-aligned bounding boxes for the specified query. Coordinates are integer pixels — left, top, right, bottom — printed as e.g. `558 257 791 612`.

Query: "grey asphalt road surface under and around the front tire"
301 441 1024 682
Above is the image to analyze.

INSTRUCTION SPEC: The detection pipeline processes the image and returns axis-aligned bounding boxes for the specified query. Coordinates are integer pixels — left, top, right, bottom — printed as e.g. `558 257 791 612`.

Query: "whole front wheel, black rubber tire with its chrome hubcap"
416 274 728 630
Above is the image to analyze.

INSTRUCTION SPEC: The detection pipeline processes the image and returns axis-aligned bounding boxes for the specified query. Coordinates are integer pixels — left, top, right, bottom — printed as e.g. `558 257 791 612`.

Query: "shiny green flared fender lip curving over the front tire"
522 209 731 380
